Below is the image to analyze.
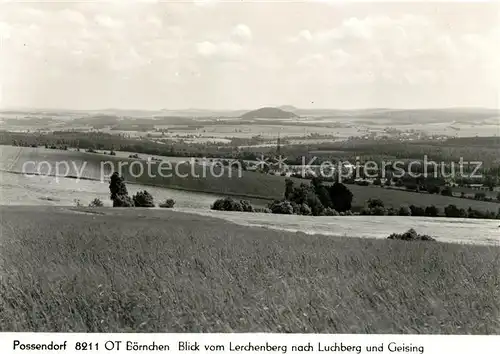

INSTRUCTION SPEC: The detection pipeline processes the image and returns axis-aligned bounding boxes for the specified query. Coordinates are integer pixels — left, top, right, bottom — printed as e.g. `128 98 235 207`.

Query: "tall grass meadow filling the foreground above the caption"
0 207 500 333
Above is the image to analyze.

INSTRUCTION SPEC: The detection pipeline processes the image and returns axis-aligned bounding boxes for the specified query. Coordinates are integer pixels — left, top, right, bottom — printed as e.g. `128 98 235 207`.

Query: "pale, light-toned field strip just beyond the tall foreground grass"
0 172 500 245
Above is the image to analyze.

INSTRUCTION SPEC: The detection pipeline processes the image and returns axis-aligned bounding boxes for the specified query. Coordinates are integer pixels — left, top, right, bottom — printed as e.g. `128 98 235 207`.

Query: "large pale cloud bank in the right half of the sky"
288 15 498 86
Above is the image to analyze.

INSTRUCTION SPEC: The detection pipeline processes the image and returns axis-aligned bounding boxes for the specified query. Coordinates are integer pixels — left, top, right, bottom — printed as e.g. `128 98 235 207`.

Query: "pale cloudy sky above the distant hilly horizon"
0 0 500 109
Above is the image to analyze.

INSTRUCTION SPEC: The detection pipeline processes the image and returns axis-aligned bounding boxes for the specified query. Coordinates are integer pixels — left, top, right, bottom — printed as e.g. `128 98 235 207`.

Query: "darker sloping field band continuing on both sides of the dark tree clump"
0 146 500 212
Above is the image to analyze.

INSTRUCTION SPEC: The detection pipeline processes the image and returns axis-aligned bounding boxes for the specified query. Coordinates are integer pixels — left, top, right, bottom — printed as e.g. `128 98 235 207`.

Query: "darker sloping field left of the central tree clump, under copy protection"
0 146 284 199
